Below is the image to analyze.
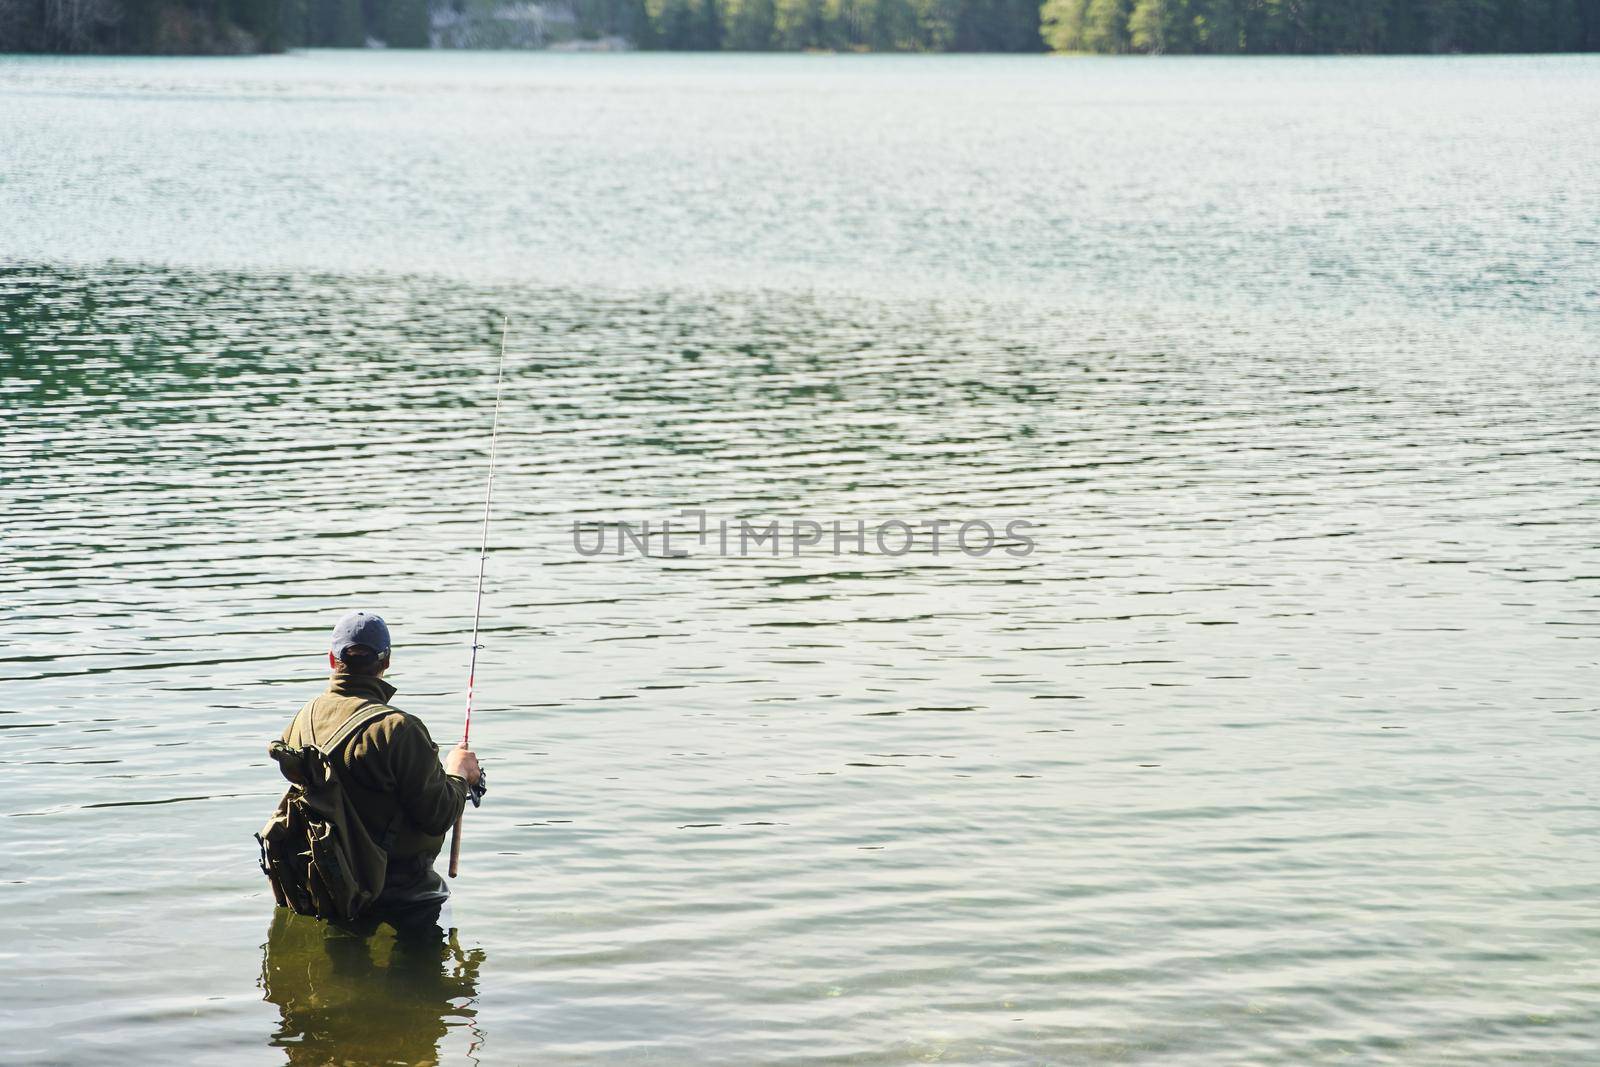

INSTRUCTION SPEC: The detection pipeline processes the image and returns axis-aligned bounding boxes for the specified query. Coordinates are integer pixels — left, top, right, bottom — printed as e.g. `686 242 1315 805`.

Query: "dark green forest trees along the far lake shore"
0 0 1600 54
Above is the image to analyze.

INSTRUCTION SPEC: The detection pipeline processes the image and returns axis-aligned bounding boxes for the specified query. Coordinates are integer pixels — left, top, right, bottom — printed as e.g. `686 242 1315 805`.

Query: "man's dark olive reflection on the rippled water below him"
261 907 483 1067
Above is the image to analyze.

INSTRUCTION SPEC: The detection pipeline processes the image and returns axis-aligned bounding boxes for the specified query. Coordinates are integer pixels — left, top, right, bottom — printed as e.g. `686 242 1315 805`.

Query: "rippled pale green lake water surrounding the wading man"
0 53 1600 1065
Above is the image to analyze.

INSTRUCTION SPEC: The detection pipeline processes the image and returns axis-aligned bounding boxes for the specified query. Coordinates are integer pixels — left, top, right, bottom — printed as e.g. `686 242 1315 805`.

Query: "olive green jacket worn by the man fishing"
283 670 467 886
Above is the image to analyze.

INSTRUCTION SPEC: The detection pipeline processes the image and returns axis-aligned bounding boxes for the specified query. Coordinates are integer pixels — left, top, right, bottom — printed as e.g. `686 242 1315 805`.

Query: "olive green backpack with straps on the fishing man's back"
256 704 394 923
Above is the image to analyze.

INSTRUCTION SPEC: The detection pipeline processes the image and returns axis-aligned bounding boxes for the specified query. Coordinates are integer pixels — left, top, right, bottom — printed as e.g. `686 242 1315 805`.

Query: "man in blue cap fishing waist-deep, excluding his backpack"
283 611 482 933
